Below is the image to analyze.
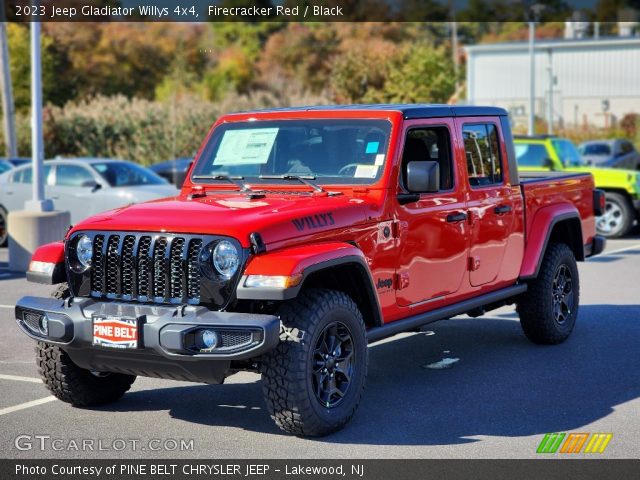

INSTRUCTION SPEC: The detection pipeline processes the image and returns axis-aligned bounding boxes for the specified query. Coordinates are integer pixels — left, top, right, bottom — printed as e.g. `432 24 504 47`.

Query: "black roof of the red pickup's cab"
232 103 507 120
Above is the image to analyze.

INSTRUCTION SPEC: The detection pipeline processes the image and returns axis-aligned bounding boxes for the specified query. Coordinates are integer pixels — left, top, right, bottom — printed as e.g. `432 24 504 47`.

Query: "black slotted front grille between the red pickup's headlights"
90 233 203 304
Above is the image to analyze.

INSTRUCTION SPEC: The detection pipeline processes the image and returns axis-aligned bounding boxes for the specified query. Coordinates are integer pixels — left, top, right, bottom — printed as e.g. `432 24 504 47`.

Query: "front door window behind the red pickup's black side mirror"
402 126 453 191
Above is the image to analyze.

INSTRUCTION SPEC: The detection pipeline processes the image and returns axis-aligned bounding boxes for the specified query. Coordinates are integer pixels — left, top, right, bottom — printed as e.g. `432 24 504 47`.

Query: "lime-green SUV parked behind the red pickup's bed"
515 136 640 238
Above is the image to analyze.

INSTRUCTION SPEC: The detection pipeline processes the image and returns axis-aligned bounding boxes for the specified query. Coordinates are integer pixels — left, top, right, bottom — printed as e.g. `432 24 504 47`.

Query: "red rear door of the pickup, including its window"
456 117 521 287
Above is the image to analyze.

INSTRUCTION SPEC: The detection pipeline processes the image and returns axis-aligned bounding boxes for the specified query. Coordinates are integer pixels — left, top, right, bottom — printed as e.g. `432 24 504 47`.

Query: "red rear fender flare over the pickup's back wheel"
520 204 584 280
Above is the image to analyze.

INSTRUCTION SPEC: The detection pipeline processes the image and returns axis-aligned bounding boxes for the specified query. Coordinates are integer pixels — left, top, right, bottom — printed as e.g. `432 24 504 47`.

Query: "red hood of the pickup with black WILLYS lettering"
73 190 366 247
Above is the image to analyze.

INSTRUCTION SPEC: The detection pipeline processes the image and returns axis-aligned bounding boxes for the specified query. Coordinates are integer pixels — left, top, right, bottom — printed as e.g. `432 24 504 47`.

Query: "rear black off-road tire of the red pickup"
516 243 580 345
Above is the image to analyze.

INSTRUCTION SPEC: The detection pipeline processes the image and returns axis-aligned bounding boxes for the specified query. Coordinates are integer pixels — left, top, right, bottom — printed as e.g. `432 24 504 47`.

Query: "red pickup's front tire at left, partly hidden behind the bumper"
36 285 136 407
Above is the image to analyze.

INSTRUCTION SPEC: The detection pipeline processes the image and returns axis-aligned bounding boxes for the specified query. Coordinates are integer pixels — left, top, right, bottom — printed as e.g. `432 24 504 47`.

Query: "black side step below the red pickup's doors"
367 283 527 343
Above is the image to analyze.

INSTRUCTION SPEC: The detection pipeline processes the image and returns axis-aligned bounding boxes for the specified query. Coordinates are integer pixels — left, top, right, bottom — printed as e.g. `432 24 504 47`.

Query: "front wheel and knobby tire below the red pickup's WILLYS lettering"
262 289 368 437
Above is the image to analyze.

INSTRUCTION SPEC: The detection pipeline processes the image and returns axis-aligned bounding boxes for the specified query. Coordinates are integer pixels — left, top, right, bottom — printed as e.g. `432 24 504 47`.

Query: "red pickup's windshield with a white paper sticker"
192 119 391 184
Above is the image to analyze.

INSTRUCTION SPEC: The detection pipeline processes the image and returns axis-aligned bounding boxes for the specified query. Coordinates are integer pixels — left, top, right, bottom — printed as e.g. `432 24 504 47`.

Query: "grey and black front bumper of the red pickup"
15 297 280 383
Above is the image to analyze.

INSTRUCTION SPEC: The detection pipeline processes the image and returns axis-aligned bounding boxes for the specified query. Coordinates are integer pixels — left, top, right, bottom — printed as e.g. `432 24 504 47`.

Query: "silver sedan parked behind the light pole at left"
0 158 178 246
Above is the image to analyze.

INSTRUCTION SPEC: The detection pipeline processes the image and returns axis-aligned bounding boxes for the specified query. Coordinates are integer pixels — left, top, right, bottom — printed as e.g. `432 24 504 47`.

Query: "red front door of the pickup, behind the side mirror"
396 119 469 306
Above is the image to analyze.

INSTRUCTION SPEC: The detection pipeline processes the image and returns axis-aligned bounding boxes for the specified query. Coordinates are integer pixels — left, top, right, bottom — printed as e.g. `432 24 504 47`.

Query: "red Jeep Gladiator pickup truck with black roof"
15 105 604 436
